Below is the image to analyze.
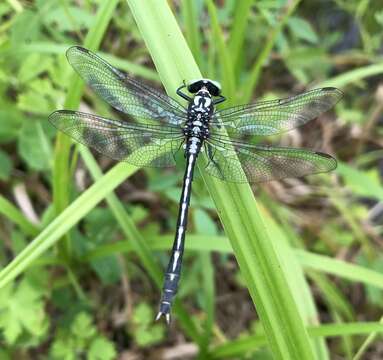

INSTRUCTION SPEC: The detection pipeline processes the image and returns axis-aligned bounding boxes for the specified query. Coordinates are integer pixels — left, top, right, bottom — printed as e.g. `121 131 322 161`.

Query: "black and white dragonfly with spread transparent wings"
49 46 342 323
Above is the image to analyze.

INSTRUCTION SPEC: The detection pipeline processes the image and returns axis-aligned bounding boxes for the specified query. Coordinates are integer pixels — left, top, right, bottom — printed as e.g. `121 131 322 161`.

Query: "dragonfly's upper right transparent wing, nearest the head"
211 87 343 140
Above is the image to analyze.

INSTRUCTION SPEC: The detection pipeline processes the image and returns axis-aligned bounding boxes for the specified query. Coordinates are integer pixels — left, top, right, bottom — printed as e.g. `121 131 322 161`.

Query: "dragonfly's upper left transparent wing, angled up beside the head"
66 46 186 125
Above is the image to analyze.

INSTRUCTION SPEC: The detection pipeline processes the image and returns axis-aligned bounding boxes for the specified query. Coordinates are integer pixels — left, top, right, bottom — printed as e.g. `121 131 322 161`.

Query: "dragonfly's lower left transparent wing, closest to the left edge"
49 110 184 167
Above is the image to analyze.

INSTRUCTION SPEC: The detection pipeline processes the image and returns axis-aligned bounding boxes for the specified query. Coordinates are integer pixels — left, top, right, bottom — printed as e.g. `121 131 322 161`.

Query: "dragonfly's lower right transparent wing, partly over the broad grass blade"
205 139 337 183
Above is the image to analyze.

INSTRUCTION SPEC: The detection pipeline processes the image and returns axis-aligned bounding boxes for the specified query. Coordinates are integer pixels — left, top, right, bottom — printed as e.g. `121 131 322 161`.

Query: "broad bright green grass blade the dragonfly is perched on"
128 0 315 359
